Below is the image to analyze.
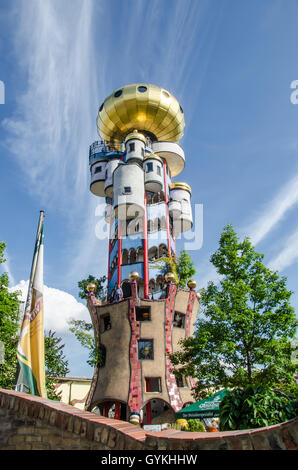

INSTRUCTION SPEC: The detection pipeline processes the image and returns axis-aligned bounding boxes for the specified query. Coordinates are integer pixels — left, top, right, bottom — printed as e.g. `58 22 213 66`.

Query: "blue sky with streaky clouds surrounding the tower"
0 0 298 376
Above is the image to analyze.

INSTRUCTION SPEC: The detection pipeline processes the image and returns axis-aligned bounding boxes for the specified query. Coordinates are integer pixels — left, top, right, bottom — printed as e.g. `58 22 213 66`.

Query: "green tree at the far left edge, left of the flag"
0 242 20 389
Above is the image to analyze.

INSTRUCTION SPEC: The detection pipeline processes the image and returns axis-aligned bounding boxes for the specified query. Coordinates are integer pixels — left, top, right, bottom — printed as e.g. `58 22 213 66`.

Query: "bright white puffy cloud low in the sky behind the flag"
9 281 91 333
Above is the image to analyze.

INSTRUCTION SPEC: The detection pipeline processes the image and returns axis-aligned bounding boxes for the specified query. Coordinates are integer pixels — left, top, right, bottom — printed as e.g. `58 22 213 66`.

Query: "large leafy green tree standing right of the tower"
170 225 297 398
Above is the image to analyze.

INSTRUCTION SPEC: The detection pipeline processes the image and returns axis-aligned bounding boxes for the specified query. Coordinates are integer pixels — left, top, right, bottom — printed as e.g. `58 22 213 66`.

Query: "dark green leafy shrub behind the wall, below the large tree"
220 385 298 431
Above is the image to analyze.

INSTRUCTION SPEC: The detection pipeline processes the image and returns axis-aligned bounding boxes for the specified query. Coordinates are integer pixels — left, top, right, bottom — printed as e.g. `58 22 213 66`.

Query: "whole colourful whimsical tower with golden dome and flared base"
87 84 200 424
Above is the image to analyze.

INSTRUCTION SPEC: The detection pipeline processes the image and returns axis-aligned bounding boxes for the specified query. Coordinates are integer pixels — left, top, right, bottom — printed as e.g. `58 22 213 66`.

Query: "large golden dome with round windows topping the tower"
97 83 185 142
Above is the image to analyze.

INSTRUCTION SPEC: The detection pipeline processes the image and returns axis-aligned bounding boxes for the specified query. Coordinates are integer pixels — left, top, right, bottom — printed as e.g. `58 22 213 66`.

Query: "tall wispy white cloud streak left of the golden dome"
2 0 98 209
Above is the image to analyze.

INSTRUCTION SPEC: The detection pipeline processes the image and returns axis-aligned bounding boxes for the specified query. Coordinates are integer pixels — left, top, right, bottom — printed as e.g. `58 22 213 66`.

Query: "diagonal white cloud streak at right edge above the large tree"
241 175 298 245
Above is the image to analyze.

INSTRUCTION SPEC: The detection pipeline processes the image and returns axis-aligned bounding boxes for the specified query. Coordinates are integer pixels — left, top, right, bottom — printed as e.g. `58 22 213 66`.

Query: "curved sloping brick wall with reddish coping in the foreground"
0 389 298 451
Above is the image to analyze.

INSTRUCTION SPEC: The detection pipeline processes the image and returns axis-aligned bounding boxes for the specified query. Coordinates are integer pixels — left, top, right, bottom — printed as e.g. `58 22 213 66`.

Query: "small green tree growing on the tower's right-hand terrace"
150 250 196 287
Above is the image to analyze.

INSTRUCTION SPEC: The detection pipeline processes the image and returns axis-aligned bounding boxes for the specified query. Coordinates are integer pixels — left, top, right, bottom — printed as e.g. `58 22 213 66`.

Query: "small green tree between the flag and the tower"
44 330 69 401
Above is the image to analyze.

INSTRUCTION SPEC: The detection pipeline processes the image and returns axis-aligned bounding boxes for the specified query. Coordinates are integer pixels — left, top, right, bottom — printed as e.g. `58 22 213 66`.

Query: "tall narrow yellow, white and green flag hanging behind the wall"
16 211 46 398
